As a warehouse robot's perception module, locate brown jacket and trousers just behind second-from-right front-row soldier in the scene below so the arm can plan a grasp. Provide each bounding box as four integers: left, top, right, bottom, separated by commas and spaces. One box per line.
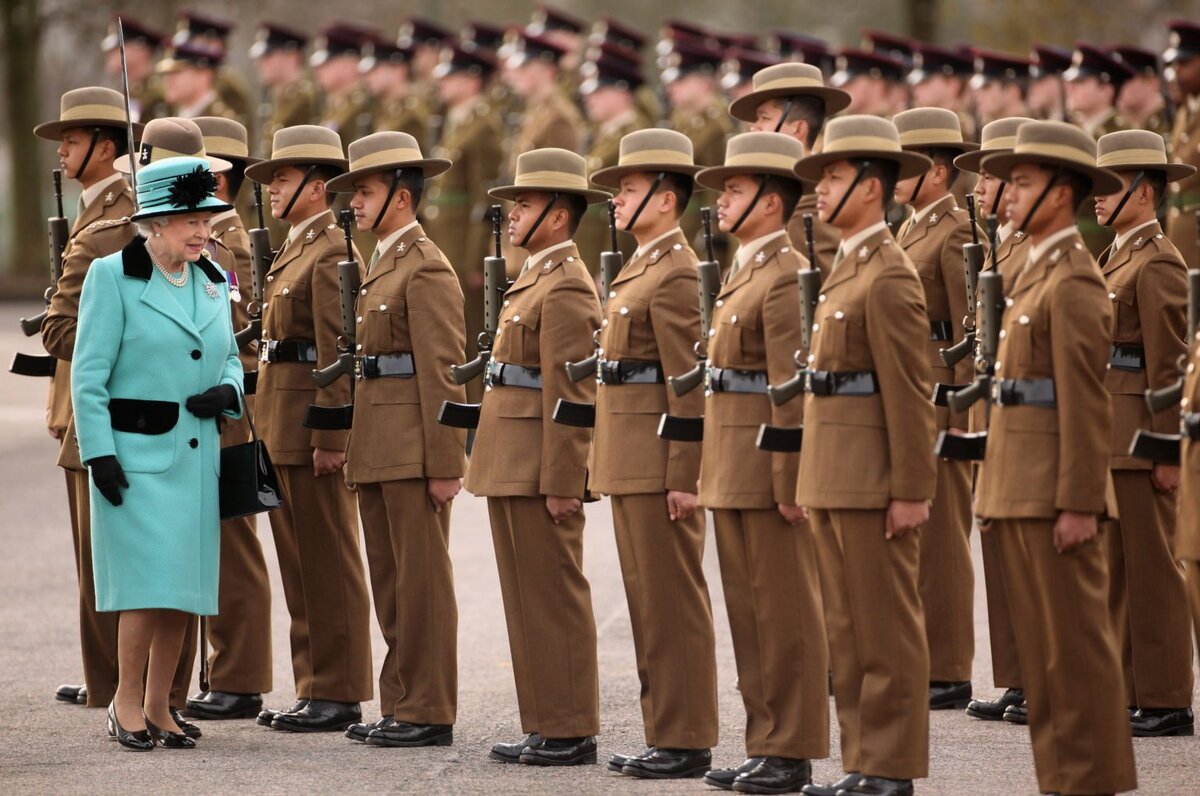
896, 196, 974, 682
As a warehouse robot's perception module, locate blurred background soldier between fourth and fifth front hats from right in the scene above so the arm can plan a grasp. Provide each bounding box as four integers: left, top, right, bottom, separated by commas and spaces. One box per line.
575, 44, 644, 267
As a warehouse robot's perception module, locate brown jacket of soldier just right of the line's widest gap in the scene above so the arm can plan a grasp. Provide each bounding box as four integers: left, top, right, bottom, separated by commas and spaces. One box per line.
464, 244, 600, 498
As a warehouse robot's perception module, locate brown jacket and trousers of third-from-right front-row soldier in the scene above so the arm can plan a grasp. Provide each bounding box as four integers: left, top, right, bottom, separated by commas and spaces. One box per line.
700, 235, 829, 759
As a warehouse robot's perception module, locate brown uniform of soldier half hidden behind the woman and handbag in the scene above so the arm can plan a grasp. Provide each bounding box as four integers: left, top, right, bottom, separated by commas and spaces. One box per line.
208, 215, 271, 694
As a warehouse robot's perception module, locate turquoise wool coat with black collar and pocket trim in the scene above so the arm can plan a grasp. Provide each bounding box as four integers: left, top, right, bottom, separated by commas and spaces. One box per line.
71, 237, 244, 615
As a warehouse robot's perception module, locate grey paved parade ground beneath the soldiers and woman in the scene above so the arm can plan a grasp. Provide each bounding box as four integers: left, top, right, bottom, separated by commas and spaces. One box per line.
0, 305, 1200, 794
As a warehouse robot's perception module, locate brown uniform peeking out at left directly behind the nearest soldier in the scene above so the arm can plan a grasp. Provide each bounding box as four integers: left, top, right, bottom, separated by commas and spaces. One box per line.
970, 225, 1030, 688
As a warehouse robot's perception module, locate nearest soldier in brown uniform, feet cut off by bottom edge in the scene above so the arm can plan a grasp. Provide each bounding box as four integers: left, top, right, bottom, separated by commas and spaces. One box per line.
976, 121, 1136, 794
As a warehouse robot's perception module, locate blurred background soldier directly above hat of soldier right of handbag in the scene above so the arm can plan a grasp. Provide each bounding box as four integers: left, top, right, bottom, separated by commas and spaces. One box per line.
250, 22, 317, 155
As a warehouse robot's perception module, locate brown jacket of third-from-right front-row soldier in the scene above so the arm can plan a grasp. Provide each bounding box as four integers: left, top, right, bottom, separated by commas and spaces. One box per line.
700, 234, 808, 509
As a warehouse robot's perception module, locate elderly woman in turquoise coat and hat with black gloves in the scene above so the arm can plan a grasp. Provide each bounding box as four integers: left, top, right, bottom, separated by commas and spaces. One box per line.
71, 157, 244, 750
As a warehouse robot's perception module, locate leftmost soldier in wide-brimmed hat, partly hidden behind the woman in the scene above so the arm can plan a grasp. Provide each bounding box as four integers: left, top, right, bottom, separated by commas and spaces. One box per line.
34, 86, 142, 707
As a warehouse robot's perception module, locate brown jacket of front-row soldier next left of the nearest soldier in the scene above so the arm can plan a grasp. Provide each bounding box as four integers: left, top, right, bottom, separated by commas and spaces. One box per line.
797, 231, 936, 509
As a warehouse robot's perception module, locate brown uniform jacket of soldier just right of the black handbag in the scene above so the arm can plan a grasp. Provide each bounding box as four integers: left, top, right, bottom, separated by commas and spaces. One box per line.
257, 211, 362, 465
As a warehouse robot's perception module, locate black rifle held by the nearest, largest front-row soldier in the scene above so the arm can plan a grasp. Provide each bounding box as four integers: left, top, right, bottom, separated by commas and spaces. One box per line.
934, 270, 1004, 461
